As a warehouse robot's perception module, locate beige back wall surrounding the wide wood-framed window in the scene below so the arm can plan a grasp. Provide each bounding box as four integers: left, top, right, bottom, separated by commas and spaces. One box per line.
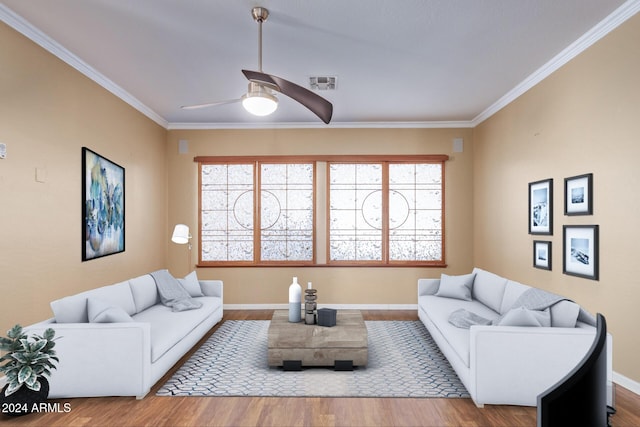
167, 129, 473, 305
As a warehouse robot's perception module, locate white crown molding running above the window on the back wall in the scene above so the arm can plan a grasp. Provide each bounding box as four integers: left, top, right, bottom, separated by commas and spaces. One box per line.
167, 120, 474, 130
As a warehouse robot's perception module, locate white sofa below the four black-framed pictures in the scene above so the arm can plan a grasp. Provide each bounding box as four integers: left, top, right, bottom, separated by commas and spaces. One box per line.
418, 268, 612, 407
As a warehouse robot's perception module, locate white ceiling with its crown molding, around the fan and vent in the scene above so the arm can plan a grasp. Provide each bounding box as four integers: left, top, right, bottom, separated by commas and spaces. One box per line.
0, 0, 640, 128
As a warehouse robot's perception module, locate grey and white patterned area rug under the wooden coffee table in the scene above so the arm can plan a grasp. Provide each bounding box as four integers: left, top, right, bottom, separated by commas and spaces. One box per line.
157, 320, 469, 398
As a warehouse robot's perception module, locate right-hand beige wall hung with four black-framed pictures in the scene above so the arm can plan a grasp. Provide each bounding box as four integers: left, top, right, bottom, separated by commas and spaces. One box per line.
473, 15, 640, 381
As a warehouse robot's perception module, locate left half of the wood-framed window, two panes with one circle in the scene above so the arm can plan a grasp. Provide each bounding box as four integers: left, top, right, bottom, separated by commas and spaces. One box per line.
200, 162, 315, 264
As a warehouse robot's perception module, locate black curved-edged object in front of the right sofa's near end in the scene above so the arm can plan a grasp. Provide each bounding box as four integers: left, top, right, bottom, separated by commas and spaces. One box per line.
537, 313, 614, 427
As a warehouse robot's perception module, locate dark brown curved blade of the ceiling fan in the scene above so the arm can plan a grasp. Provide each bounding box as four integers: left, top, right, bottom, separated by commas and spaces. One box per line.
242, 70, 333, 124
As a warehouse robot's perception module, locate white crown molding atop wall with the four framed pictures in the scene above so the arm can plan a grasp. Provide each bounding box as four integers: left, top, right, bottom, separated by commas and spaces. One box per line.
471, 0, 640, 127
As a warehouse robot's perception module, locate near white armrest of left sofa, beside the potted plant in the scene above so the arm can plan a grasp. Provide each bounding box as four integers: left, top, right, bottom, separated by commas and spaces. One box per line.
25, 319, 153, 398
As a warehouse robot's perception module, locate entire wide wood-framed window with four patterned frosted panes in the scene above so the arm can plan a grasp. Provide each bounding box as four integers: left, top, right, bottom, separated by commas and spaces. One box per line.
195, 156, 448, 266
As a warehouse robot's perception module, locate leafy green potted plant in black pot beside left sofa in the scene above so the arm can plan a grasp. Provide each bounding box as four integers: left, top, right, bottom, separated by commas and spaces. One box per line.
0, 325, 59, 415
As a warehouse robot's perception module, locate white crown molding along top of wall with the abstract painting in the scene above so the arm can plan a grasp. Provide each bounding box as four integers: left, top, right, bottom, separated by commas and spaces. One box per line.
0, 4, 167, 128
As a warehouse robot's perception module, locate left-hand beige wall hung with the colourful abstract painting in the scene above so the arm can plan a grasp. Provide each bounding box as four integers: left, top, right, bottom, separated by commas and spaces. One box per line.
0, 23, 168, 335
